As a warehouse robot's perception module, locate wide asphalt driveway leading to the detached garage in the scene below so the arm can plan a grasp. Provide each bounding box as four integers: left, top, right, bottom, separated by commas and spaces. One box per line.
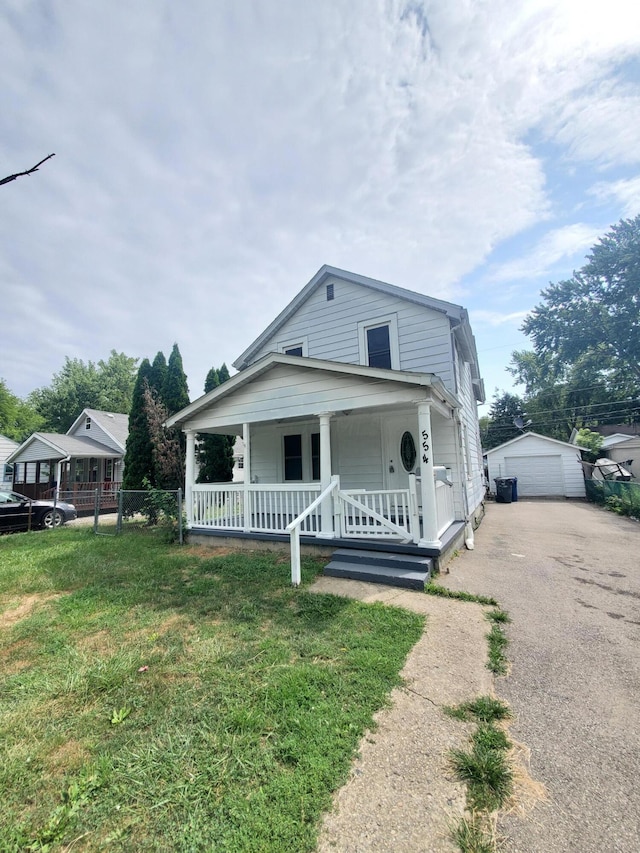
441, 501, 640, 853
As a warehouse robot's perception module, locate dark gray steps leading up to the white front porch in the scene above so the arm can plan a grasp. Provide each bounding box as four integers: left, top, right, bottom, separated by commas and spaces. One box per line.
323, 548, 433, 590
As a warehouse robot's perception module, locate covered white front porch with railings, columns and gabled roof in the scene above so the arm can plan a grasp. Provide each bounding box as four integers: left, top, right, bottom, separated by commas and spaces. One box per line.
167, 355, 476, 582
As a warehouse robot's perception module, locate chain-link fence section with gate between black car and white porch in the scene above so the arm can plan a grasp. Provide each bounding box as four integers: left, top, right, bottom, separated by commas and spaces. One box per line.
93, 489, 184, 545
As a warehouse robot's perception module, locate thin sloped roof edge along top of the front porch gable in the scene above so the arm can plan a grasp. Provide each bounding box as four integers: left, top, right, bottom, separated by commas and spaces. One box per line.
165, 353, 459, 428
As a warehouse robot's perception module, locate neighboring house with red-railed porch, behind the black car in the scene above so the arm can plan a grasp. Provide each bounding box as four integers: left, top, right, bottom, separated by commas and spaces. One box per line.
7, 409, 129, 504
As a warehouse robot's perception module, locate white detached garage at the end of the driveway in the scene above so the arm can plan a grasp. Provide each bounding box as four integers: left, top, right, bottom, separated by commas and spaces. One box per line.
487, 432, 585, 498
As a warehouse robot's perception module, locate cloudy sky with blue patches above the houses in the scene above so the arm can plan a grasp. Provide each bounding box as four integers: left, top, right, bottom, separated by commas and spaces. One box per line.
0, 0, 640, 412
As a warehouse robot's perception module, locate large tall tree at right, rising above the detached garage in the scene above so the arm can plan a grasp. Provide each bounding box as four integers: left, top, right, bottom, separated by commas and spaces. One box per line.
522, 215, 640, 388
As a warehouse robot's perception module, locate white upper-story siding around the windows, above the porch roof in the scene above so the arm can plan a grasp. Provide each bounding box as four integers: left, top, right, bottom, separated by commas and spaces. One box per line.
251, 279, 454, 391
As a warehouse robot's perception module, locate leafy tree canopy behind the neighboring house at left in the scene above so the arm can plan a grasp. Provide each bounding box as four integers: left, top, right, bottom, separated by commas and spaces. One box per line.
28, 350, 138, 433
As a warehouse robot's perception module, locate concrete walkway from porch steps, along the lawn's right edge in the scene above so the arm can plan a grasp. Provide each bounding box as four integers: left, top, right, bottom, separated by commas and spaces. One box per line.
311, 577, 492, 853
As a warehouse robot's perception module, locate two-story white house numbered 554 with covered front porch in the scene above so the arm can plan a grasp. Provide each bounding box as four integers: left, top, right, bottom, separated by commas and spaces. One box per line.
167, 266, 484, 554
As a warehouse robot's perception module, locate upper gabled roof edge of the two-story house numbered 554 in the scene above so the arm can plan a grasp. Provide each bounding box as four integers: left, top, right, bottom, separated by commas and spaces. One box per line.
233, 264, 478, 378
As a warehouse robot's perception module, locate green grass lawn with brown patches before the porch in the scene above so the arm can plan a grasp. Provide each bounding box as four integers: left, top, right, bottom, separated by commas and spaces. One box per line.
0, 529, 423, 853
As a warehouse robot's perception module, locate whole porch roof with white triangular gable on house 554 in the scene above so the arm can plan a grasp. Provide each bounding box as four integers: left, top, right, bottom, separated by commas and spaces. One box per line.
165, 353, 460, 432
